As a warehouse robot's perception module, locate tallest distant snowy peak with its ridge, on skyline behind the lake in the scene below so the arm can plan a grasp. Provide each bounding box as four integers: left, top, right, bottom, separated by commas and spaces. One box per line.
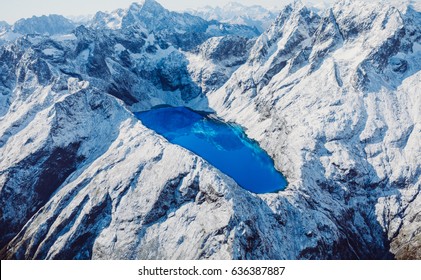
90, 0, 259, 50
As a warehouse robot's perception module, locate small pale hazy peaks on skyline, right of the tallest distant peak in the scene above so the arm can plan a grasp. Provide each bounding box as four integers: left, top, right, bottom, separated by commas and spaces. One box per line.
187, 2, 278, 32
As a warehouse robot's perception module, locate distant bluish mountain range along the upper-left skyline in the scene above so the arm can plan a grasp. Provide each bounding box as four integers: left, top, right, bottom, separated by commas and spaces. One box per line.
0, 0, 260, 49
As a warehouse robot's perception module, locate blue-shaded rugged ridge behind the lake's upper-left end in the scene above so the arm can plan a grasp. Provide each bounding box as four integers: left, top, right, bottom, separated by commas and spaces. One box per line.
0, 23, 207, 120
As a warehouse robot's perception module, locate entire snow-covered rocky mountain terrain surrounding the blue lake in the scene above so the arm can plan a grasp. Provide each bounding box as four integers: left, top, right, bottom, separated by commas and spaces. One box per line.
0, 0, 421, 259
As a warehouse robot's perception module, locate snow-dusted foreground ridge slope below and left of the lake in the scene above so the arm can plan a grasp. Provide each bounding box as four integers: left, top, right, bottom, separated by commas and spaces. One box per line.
0, 78, 286, 259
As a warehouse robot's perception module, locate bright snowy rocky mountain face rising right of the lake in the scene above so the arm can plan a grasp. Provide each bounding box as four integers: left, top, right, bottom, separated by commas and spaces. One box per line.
209, 1, 421, 258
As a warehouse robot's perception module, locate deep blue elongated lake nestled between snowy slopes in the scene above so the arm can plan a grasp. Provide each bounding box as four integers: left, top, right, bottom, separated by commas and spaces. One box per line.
136, 107, 286, 193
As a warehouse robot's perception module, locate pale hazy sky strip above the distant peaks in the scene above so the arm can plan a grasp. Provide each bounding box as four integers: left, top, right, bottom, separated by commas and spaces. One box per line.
0, 0, 289, 23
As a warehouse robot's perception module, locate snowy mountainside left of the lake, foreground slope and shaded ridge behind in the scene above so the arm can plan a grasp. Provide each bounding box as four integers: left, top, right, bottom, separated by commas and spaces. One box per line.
0, 20, 279, 259
